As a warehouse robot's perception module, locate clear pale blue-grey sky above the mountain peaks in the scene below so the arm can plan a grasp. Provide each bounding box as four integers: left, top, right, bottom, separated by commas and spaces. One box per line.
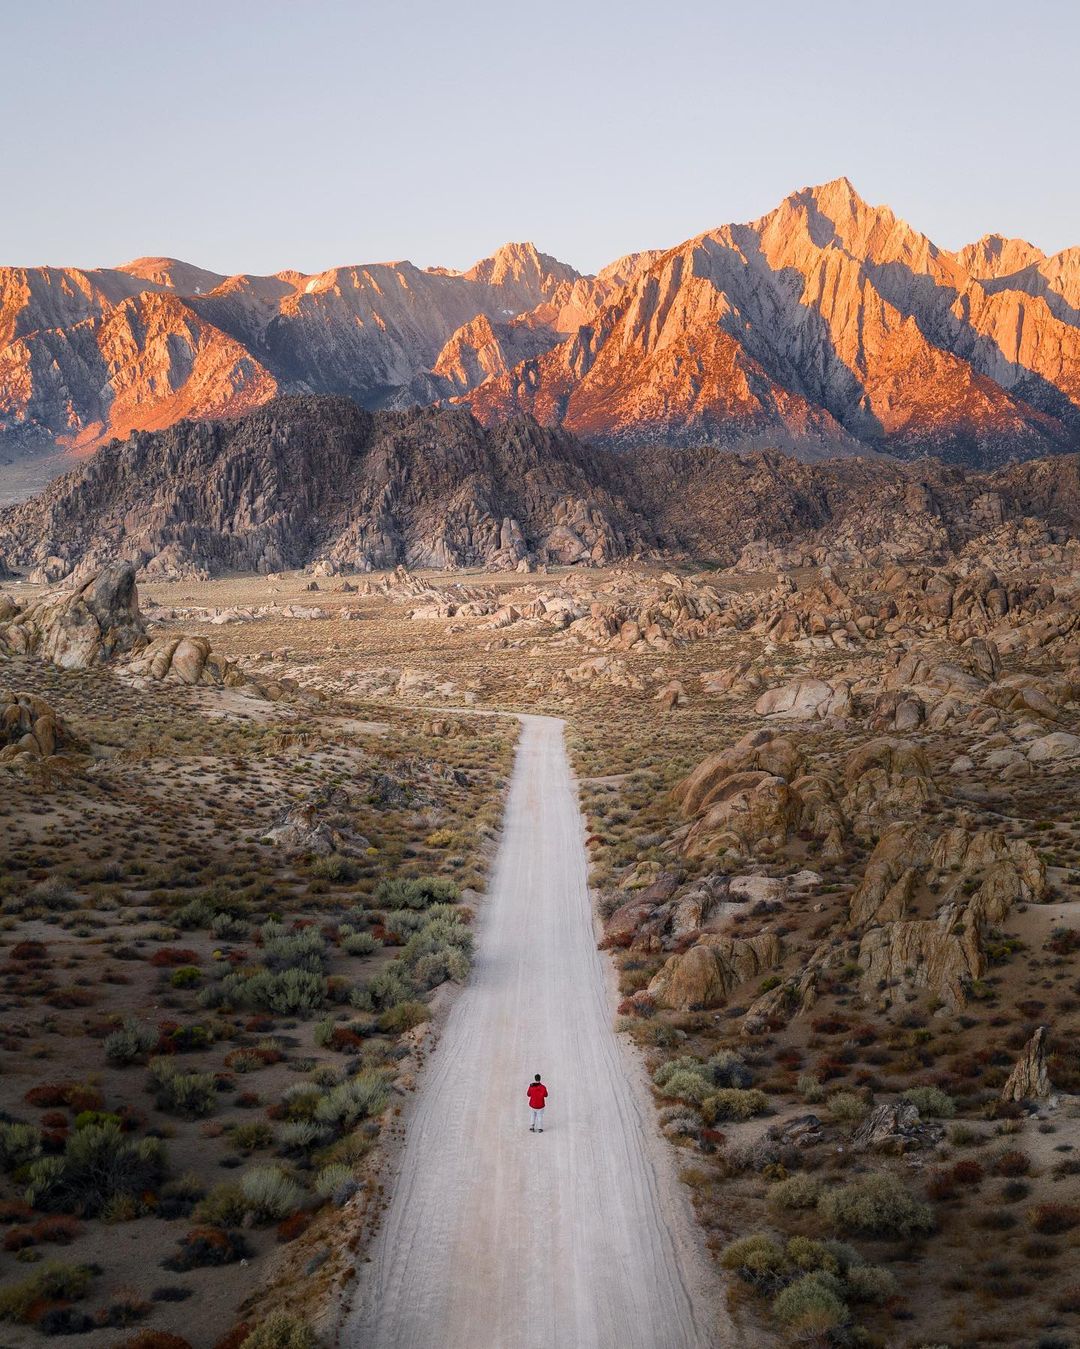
0, 0, 1080, 272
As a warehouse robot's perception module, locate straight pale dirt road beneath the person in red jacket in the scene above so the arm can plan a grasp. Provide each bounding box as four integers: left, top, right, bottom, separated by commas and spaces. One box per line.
342, 716, 733, 1349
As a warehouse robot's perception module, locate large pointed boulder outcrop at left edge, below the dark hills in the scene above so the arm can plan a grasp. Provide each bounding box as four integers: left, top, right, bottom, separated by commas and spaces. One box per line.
0, 563, 146, 669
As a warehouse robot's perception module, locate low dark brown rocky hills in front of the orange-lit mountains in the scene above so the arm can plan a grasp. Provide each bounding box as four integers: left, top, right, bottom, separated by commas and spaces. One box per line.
0, 395, 1080, 581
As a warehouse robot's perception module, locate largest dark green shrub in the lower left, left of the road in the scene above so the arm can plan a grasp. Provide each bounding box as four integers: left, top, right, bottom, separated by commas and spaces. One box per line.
26, 1124, 166, 1217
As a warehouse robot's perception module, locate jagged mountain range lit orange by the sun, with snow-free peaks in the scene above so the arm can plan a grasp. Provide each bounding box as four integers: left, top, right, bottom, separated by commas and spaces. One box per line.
0, 178, 1080, 468
